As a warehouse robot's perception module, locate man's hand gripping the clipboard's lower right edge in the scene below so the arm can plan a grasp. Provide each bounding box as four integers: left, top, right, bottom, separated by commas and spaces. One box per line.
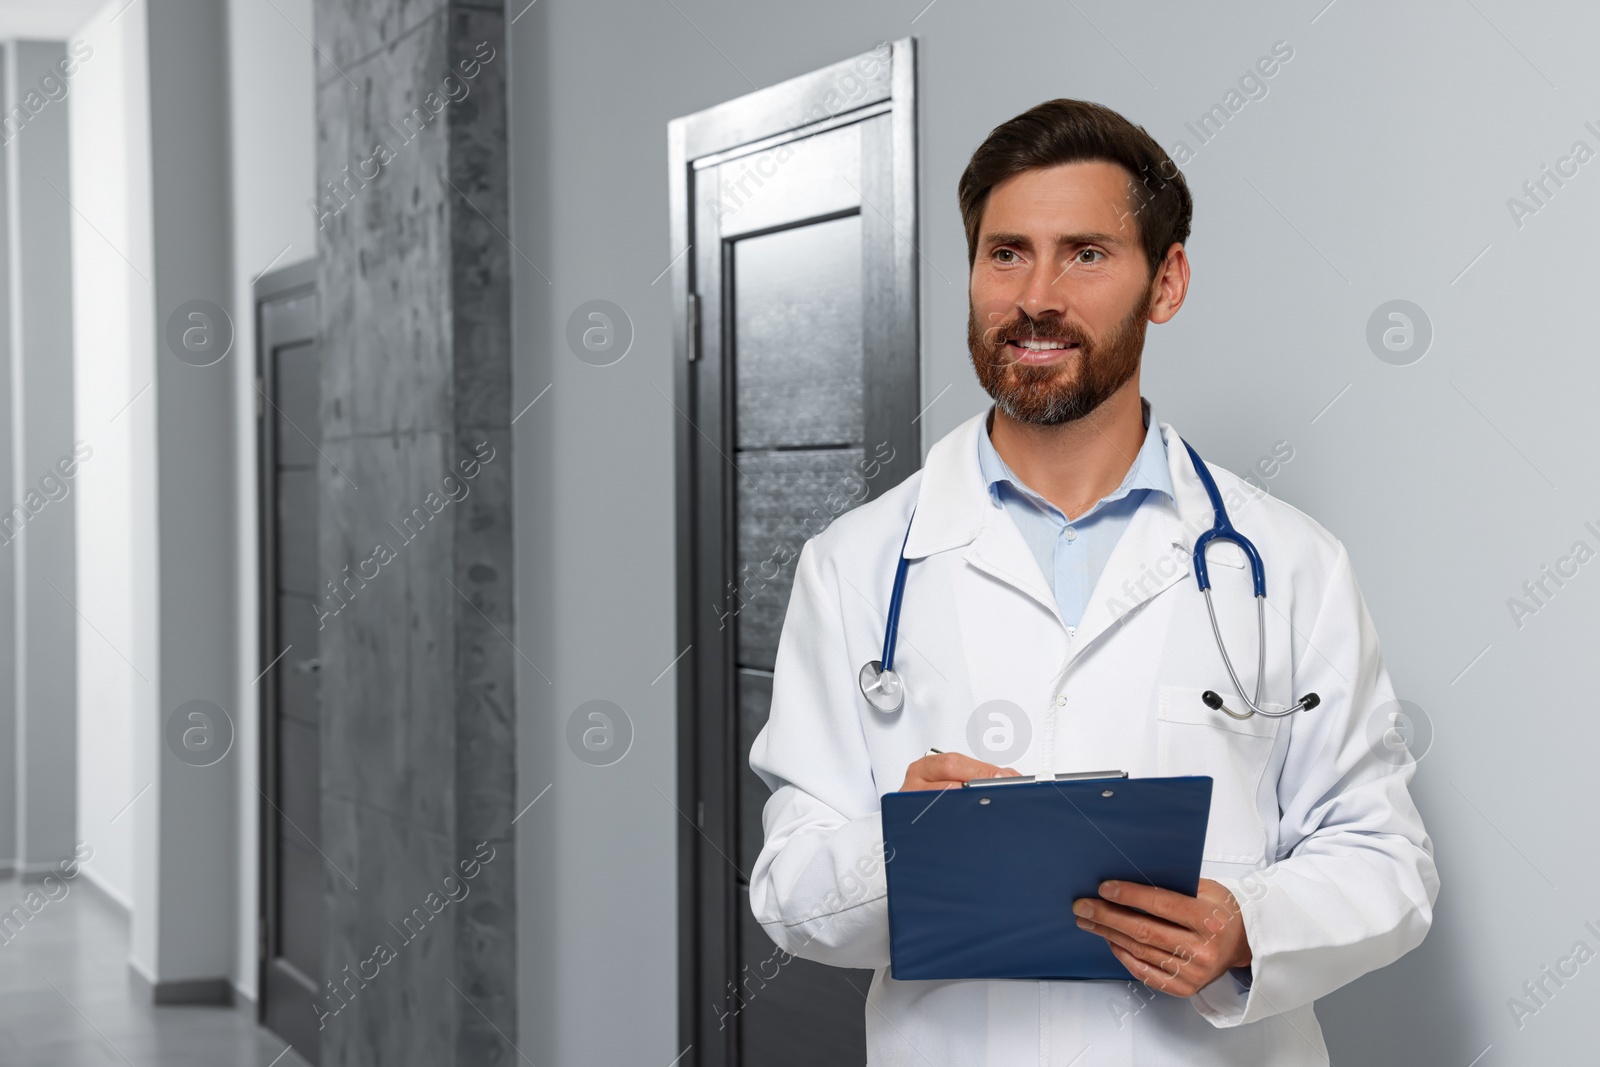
1075, 883, 1250, 997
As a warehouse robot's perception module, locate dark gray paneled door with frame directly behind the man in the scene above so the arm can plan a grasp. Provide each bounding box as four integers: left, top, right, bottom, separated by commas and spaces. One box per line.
677, 42, 920, 1067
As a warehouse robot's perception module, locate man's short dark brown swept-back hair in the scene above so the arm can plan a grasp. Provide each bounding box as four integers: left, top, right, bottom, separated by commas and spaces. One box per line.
958, 99, 1194, 277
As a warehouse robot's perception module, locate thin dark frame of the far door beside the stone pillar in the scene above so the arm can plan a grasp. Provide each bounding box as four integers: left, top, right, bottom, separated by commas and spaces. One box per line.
251, 258, 318, 1062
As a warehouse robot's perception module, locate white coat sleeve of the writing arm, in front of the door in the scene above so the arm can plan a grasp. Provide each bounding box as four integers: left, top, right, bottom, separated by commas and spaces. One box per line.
750, 541, 890, 968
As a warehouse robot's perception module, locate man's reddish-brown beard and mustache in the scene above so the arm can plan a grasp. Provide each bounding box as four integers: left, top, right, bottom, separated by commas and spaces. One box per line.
966, 291, 1152, 426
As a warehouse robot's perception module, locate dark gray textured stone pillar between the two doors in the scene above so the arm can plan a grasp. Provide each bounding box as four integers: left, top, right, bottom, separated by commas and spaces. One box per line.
314, 0, 525, 1067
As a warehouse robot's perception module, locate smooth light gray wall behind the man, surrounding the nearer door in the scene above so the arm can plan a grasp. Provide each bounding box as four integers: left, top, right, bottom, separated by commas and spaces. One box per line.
509, 0, 1600, 1065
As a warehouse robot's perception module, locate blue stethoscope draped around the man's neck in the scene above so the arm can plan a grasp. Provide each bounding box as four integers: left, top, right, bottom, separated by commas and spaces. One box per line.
859, 442, 1322, 718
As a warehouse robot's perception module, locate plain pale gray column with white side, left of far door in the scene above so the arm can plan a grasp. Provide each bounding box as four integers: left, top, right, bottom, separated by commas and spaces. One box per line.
125, 0, 236, 1003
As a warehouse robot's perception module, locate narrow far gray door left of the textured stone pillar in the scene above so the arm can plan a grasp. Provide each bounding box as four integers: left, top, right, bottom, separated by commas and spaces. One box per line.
256, 262, 325, 1064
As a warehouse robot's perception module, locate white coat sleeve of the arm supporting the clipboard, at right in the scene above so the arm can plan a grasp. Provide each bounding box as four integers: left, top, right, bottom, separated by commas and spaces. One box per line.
1194, 545, 1438, 1027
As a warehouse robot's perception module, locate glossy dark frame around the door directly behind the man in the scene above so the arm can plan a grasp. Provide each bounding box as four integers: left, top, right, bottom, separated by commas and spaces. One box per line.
667, 37, 922, 1067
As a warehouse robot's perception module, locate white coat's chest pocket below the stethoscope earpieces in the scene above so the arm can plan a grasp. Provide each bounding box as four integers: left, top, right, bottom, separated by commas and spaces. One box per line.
1155, 685, 1278, 864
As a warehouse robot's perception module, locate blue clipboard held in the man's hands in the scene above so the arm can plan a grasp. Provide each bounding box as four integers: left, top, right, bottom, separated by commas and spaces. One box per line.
882, 776, 1211, 981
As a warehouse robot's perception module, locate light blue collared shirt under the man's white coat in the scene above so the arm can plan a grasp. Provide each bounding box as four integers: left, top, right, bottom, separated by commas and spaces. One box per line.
978, 400, 1173, 630
